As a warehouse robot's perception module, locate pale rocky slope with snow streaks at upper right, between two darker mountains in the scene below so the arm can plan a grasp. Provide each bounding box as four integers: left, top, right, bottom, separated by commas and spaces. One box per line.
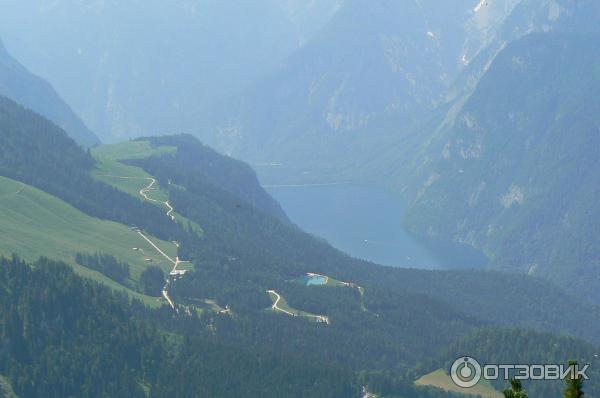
330, 0, 600, 191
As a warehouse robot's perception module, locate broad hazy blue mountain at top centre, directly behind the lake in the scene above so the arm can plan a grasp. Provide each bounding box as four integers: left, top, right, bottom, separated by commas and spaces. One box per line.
209, 0, 476, 175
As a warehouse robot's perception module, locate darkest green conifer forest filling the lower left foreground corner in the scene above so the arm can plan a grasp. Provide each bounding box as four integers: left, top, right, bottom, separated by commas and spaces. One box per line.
0, 258, 359, 398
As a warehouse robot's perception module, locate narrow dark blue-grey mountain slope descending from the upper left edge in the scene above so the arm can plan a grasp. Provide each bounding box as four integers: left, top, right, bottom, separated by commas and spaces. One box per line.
0, 37, 100, 146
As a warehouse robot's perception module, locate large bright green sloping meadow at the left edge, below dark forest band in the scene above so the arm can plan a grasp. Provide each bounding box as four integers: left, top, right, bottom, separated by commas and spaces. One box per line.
0, 177, 177, 305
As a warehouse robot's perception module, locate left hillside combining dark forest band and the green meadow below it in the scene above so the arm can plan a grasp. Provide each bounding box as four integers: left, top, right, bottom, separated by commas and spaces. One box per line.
0, 97, 195, 306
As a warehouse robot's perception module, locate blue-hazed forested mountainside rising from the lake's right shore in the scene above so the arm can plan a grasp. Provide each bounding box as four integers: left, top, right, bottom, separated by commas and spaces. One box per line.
407, 34, 600, 303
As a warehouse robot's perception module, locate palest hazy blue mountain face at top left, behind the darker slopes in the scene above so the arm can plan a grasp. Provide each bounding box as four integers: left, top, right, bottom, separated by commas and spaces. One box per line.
0, 0, 298, 142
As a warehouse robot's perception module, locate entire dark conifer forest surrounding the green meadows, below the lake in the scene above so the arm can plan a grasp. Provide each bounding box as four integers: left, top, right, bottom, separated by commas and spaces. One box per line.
0, 100, 600, 398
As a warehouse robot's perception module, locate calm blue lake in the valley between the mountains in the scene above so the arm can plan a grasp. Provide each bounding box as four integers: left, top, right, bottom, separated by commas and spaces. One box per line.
266, 184, 486, 269
